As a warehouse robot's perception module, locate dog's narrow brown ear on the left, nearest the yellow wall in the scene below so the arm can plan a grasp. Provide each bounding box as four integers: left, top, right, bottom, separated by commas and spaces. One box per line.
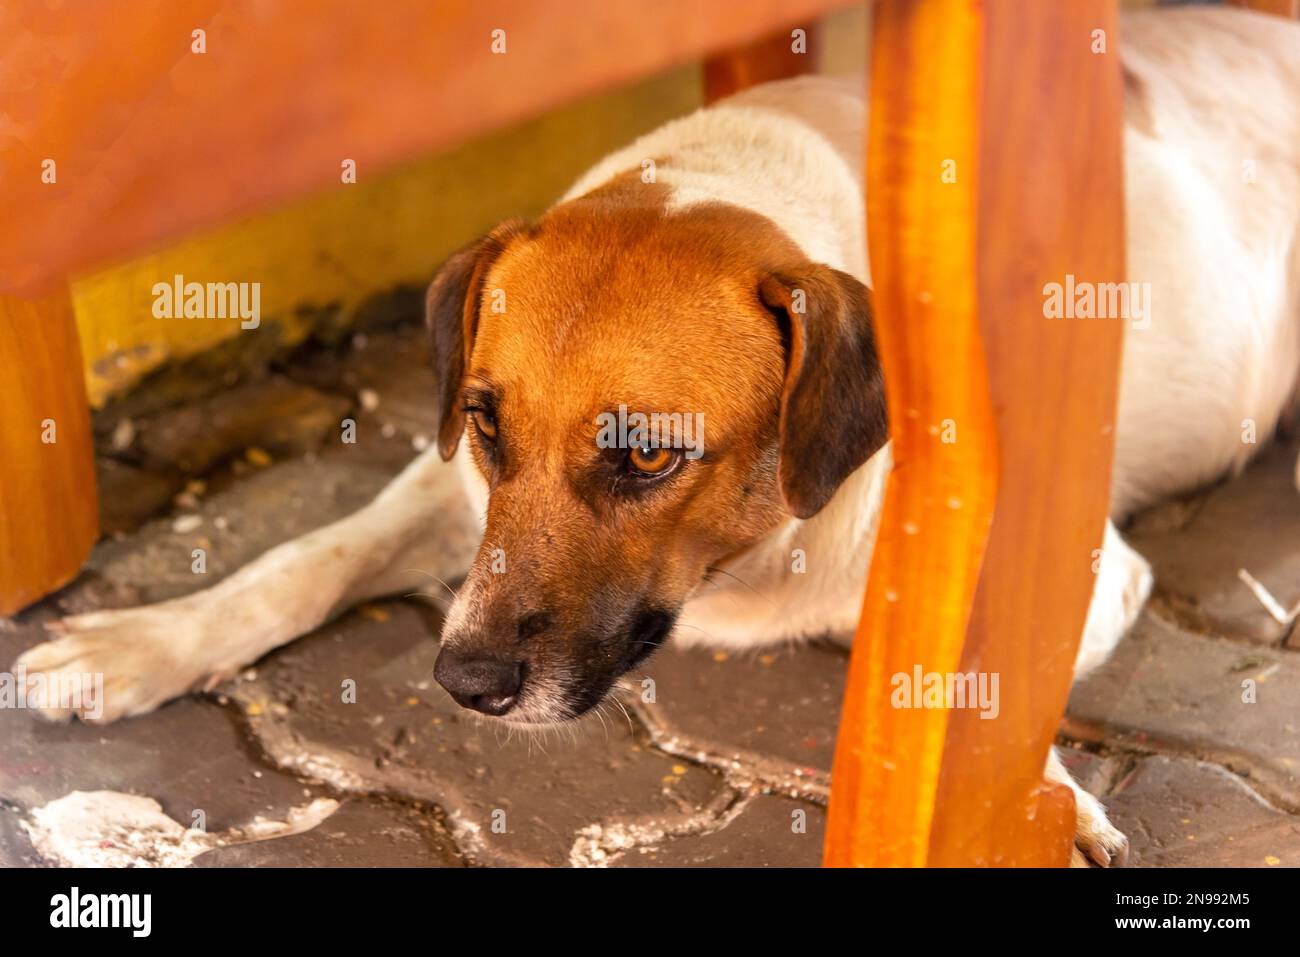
424, 220, 524, 459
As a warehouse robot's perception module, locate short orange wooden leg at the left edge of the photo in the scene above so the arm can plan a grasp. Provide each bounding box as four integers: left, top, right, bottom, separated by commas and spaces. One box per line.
0, 290, 99, 615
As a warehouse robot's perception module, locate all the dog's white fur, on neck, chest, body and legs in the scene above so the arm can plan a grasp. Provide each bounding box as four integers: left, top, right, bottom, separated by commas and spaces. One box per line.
12, 3, 1300, 863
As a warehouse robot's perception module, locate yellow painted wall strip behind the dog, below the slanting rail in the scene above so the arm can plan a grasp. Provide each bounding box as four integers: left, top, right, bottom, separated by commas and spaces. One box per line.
72, 68, 702, 408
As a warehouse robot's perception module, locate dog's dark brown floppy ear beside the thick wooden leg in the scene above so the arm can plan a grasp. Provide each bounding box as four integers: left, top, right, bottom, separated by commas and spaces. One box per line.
758, 265, 889, 519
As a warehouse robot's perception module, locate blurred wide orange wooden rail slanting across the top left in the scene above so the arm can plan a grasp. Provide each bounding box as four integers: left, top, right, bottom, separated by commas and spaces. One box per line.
0, 0, 853, 294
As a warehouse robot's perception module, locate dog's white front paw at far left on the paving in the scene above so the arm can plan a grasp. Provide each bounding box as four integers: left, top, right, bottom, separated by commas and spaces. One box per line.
14, 602, 208, 723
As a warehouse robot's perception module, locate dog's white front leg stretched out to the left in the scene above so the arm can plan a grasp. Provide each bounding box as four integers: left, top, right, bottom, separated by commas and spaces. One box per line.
16, 447, 478, 722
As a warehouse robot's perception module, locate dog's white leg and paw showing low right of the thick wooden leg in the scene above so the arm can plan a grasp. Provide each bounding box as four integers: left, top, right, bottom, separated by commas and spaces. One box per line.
1044, 520, 1152, 867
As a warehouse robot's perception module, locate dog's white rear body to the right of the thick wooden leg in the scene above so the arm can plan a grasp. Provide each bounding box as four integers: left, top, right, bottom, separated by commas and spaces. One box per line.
1112, 9, 1300, 520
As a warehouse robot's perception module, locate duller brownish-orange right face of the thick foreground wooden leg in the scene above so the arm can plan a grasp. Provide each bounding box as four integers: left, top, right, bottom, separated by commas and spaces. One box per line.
930, 0, 1141, 866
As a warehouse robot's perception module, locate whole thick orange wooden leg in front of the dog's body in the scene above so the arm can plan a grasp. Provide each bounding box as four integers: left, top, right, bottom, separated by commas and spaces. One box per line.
826, 0, 1125, 866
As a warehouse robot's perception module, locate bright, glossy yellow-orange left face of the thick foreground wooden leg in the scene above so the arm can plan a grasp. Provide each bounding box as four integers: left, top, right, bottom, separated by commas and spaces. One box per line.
826, 0, 997, 866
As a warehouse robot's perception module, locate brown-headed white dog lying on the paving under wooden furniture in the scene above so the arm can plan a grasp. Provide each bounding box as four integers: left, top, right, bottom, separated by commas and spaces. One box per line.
12, 3, 1300, 865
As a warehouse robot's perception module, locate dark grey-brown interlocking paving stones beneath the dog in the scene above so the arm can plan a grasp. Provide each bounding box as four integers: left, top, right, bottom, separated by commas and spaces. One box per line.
0, 321, 1300, 867
